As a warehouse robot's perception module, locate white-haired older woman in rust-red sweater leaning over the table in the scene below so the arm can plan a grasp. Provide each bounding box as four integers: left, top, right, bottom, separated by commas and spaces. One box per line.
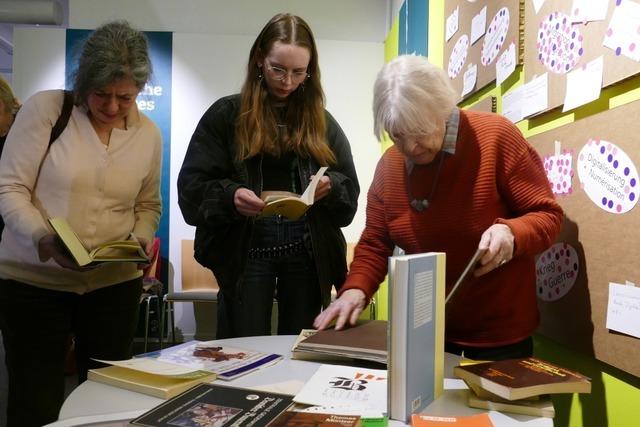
315, 55, 563, 360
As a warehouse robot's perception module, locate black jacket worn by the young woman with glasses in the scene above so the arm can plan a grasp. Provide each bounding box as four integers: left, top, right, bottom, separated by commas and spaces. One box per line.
178, 95, 360, 305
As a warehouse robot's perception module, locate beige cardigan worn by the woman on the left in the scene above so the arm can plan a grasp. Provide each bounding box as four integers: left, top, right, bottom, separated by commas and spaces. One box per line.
0, 90, 162, 294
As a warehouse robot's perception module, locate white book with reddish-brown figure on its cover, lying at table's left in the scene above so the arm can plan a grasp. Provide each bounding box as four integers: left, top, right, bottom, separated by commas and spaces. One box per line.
137, 341, 282, 380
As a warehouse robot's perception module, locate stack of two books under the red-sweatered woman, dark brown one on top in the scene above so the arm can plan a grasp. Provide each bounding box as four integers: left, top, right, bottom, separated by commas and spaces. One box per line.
453, 357, 591, 418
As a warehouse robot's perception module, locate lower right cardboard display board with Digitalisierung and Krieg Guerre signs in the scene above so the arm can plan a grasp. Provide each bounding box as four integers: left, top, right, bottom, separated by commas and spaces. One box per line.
529, 101, 640, 376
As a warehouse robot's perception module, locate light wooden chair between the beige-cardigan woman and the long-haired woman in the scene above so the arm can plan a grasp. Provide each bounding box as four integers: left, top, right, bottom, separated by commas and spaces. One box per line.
160, 240, 219, 348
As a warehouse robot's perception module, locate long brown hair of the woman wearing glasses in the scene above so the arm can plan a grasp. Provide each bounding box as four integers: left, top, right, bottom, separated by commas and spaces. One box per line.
236, 13, 336, 165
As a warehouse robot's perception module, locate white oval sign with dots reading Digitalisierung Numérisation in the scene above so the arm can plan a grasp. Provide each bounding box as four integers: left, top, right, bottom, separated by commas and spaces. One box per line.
577, 139, 638, 214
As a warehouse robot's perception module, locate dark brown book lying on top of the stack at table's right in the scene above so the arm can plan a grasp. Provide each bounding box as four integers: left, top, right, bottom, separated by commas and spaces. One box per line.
453, 357, 591, 400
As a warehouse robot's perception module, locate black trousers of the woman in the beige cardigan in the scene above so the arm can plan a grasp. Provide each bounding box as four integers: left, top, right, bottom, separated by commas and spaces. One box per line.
0, 279, 142, 427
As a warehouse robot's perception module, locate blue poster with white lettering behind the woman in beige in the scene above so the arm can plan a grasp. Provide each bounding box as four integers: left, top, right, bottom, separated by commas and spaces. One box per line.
65, 29, 173, 268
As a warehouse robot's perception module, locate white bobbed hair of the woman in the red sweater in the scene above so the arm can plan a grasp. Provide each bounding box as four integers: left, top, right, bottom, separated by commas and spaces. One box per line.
373, 55, 458, 140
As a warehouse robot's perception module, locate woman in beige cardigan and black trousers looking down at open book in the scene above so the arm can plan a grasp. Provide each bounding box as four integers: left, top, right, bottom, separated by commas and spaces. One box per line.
0, 22, 162, 427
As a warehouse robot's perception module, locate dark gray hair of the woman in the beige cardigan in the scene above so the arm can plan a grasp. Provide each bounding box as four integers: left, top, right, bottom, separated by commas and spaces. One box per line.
73, 21, 152, 104
